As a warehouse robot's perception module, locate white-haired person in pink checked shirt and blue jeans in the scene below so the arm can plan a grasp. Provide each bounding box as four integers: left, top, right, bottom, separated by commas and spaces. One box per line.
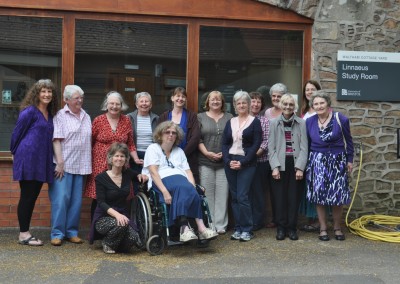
49, 85, 92, 246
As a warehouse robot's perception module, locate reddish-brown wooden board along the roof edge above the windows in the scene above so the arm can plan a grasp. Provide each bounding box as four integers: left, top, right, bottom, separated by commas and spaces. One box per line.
0, 0, 312, 24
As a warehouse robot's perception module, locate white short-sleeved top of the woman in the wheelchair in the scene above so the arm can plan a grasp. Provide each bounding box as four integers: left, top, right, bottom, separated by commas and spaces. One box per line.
142, 143, 190, 188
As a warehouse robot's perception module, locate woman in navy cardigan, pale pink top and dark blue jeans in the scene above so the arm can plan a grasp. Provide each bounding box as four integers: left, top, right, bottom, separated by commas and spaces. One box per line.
222, 91, 262, 242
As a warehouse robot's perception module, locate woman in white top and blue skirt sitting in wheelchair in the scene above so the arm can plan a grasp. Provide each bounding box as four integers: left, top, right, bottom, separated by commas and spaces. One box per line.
142, 121, 218, 242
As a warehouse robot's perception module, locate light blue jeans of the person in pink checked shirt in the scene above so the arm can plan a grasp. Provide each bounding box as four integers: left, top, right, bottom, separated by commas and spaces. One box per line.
49, 172, 83, 240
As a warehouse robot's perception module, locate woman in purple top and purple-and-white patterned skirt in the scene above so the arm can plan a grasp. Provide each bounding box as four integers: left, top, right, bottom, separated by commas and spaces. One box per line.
306, 91, 354, 241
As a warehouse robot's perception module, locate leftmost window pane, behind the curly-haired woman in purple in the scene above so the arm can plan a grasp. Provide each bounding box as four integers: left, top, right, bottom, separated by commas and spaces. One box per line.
0, 16, 62, 151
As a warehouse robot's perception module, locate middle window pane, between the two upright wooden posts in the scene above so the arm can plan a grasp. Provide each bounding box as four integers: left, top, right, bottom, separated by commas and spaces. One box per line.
75, 20, 187, 119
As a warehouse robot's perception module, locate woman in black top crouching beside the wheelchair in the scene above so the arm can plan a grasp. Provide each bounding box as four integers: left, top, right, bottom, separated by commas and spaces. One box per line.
90, 142, 148, 253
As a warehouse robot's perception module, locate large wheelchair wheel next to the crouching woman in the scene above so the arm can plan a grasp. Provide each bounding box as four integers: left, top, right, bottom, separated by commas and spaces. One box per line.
131, 192, 153, 244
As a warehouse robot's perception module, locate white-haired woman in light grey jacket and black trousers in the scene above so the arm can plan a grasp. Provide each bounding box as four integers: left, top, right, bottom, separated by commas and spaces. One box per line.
268, 94, 308, 241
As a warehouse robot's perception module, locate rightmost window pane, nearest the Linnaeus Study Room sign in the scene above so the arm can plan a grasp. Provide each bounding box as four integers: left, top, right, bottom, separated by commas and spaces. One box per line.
199, 27, 303, 111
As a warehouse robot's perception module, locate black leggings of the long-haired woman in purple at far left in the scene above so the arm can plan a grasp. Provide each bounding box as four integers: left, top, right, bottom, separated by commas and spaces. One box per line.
17, 180, 43, 232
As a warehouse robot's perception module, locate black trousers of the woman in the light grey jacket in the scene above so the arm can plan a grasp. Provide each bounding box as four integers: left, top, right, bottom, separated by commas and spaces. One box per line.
271, 156, 304, 231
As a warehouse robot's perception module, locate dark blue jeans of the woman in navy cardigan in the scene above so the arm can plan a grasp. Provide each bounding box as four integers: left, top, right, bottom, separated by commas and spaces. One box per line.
225, 165, 256, 232
